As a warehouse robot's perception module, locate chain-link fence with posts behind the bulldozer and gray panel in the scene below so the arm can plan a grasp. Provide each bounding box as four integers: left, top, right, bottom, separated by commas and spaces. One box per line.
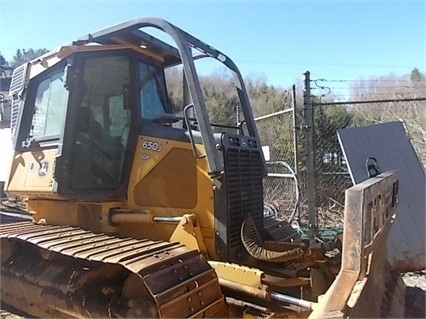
251, 74, 426, 232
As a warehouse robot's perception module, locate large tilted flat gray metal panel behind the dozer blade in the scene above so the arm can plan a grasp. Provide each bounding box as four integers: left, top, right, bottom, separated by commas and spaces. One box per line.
337, 122, 426, 271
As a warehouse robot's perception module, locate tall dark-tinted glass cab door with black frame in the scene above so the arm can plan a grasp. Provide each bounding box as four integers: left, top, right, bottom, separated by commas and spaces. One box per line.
59, 50, 136, 200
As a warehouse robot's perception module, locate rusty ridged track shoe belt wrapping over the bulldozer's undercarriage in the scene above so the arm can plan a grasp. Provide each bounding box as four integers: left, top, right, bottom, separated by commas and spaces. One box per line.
0, 222, 223, 318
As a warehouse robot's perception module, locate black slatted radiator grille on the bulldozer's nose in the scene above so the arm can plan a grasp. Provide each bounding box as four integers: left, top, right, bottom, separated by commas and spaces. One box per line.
224, 138, 263, 259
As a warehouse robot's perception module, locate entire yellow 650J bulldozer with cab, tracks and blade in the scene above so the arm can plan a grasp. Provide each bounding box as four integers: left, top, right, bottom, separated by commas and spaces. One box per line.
0, 18, 404, 318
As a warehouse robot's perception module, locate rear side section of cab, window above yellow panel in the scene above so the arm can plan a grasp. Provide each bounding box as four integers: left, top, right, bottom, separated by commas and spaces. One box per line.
7, 63, 69, 194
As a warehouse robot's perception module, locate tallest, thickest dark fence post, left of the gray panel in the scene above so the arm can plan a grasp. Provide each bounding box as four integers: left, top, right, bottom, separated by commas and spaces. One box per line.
303, 71, 316, 244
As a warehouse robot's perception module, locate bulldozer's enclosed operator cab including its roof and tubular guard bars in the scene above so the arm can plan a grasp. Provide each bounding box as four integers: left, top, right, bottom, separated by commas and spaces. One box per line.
9, 18, 264, 200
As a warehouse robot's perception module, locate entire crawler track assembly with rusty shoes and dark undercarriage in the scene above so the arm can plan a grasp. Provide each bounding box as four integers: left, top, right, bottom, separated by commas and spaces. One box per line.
0, 222, 225, 318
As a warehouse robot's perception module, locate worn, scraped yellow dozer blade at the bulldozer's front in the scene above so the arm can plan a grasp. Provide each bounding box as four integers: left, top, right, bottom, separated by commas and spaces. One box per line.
310, 171, 403, 318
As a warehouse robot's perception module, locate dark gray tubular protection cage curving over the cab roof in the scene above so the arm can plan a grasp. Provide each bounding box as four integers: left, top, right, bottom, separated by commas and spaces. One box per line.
74, 18, 266, 176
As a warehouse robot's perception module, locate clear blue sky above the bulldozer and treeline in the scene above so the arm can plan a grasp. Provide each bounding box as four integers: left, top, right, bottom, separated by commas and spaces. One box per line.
0, 0, 426, 87
